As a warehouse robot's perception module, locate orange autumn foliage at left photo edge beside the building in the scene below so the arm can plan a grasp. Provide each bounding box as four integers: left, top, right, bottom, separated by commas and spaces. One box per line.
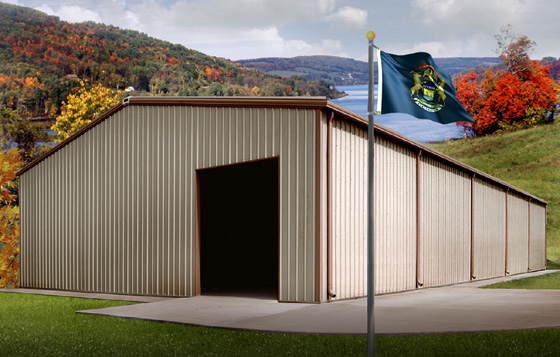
0, 149, 21, 288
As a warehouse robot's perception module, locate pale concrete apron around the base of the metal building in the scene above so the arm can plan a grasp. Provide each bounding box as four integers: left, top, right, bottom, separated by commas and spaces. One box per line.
2, 271, 560, 335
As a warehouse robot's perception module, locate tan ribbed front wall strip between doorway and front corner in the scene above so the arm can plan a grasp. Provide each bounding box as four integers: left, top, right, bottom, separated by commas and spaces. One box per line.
278, 109, 315, 301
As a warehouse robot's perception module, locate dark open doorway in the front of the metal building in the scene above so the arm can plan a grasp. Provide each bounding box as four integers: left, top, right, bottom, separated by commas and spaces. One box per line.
198, 158, 279, 299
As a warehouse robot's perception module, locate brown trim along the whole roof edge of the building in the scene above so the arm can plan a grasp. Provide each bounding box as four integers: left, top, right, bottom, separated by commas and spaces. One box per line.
16, 97, 548, 205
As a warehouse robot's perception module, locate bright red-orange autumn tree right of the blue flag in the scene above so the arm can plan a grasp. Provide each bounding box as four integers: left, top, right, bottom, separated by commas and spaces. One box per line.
455, 27, 558, 135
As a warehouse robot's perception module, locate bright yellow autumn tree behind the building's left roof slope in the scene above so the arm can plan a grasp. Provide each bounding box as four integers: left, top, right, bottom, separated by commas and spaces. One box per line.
51, 81, 124, 141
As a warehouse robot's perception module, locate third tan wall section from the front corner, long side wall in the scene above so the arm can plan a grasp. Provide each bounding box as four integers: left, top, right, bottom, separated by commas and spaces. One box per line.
473, 179, 506, 279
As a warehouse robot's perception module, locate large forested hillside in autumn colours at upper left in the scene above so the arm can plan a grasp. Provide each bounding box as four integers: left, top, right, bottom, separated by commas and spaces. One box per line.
0, 3, 342, 116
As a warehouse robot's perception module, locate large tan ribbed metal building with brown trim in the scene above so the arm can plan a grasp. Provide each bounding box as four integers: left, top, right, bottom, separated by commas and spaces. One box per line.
19, 97, 546, 302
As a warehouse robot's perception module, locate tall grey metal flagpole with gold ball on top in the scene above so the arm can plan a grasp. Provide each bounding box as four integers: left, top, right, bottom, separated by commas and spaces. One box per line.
366, 31, 379, 357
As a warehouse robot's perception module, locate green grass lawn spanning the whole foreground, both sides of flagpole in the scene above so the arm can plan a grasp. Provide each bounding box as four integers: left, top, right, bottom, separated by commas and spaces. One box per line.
0, 292, 560, 357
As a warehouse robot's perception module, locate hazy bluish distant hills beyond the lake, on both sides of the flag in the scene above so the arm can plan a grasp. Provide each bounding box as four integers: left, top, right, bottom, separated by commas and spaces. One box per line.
237, 56, 502, 85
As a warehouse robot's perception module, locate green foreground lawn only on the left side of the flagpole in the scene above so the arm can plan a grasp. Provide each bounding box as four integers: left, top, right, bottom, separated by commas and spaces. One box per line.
0, 293, 366, 356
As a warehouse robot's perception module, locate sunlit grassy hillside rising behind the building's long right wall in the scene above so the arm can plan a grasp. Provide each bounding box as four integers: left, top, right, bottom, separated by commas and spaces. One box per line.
432, 122, 560, 269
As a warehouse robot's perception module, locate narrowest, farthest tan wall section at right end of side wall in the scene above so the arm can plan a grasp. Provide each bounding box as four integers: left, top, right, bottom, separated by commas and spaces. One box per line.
529, 202, 546, 271
